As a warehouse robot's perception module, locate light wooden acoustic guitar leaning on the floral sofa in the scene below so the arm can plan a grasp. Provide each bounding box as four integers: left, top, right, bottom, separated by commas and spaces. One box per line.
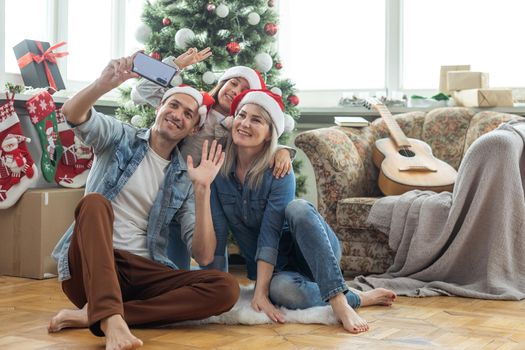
365, 99, 457, 196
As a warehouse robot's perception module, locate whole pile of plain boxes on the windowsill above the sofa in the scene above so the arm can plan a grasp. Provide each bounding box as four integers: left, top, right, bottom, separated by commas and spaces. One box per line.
439, 65, 513, 107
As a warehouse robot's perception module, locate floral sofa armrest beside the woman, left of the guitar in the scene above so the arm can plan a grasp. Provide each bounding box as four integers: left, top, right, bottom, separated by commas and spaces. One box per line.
295, 127, 369, 228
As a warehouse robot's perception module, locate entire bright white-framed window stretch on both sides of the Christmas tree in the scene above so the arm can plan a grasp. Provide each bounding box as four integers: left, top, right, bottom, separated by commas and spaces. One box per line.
0, 0, 525, 102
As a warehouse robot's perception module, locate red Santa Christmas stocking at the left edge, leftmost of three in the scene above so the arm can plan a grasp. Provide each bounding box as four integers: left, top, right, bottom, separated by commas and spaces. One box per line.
0, 96, 38, 209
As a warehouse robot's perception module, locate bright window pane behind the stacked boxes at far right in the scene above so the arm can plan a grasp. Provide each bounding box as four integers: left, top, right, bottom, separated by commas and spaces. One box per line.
403, 0, 525, 89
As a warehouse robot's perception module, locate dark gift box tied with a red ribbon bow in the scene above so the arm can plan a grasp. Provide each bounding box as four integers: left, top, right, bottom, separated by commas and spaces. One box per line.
13, 39, 69, 91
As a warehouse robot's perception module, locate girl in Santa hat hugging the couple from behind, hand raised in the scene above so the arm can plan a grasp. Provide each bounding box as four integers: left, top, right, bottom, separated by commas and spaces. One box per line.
131, 47, 295, 177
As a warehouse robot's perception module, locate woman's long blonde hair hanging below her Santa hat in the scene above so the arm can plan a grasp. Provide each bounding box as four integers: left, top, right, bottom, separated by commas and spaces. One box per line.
221, 104, 277, 190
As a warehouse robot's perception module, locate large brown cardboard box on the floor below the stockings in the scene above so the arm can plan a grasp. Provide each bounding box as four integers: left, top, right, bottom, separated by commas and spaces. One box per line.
0, 188, 84, 279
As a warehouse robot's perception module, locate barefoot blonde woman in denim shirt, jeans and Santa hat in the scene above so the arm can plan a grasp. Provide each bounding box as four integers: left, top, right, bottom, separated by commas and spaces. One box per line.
208, 90, 396, 333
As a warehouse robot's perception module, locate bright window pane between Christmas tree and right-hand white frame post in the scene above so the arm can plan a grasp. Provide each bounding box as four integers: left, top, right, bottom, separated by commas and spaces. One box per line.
279, 0, 385, 90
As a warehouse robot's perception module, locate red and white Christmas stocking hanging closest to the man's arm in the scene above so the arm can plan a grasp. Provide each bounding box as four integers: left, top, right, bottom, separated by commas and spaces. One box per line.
55, 109, 93, 188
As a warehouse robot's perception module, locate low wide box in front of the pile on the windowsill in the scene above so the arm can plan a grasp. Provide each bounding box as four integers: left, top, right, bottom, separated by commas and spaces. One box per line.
454, 89, 514, 107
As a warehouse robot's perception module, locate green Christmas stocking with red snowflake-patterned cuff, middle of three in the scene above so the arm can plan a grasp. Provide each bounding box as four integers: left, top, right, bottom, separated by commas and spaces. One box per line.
26, 91, 62, 182
